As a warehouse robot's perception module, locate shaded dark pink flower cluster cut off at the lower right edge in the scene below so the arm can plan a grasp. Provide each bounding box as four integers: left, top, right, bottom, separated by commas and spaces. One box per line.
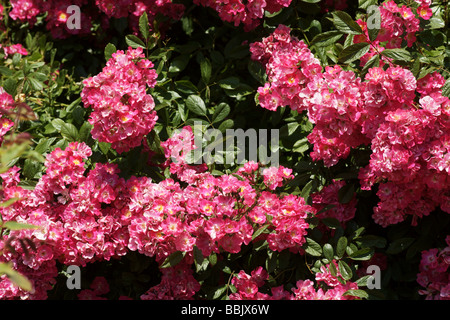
417, 236, 450, 300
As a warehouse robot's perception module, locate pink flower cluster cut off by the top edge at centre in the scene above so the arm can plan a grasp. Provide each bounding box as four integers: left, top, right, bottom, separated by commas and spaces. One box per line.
194, 0, 292, 31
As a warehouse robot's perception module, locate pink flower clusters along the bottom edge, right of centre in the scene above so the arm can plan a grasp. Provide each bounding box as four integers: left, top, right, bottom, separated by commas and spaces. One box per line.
230, 261, 358, 300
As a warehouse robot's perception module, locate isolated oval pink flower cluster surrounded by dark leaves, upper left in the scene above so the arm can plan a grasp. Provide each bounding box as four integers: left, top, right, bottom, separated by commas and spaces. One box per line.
81, 48, 158, 153
